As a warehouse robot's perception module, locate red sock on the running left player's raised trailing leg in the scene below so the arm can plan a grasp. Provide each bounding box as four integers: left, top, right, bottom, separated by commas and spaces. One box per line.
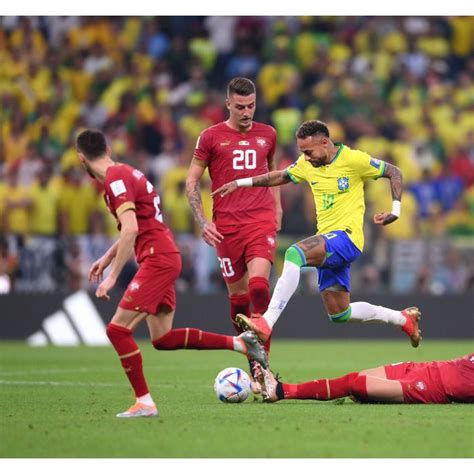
152, 328, 234, 351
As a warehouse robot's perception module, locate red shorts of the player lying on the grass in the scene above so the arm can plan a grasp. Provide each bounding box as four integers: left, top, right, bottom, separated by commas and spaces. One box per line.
385, 362, 451, 403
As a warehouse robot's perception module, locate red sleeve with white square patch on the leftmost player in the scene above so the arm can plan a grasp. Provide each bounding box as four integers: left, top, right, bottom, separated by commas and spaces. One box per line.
104, 166, 137, 217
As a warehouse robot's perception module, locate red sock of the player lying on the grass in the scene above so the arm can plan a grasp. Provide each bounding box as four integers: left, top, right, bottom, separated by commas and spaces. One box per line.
281, 372, 359, 400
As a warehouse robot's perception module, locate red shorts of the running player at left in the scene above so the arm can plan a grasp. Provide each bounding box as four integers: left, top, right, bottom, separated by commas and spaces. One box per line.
119, 253, 181, 314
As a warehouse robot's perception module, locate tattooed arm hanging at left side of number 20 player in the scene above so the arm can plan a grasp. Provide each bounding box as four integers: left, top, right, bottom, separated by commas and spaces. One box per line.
186, 161, 224, 247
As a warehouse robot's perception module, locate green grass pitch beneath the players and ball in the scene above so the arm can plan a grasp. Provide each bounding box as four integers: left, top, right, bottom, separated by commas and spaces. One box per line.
0, 340, 474, 458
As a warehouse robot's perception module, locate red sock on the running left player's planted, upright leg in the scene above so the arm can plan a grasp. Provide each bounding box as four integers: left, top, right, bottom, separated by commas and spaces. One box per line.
107, 323, 149, 398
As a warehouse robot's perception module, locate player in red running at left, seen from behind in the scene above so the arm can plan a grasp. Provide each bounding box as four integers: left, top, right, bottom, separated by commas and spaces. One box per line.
76, 130, 267, 418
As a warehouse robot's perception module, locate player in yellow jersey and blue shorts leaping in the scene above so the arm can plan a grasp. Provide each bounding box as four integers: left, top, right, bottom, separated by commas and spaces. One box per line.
212, 120, 421, 347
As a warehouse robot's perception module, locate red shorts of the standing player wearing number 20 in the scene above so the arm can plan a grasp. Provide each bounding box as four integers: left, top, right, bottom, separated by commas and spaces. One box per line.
216, 222, 276, 283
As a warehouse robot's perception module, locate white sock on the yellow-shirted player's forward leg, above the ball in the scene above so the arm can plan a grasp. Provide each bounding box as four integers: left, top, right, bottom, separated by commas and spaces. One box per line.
263, 260, 301, 328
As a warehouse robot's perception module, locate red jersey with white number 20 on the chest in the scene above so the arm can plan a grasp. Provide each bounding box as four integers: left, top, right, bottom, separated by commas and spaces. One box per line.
194, 122, 276, 227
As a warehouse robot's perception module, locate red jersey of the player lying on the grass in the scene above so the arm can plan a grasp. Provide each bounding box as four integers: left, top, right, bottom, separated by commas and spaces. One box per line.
434, 353, 474, 403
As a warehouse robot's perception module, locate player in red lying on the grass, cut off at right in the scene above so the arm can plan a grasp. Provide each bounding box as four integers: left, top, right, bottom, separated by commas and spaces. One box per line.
260, 353, 474, 403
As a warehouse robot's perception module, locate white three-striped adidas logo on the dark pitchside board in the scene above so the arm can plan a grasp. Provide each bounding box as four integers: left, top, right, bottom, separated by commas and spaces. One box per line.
26, 291, 109, 346
